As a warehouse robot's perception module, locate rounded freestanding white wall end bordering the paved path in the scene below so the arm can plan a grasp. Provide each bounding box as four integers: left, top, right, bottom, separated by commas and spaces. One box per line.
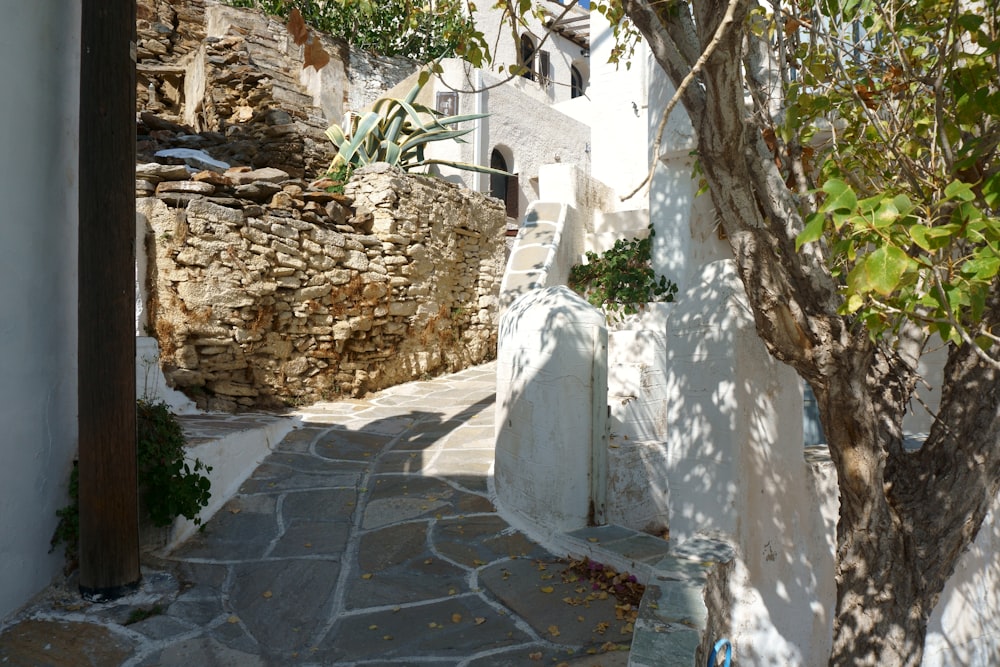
494, 286, 607, 532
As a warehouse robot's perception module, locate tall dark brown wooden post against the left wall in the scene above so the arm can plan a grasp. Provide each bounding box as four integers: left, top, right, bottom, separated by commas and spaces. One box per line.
78, 0, 140, 600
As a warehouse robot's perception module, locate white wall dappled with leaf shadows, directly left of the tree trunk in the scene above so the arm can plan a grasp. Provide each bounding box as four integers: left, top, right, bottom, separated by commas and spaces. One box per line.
667, 260, 833, 665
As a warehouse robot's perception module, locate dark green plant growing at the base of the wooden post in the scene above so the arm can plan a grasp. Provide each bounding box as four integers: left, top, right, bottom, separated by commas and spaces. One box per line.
51, 400, 212, 564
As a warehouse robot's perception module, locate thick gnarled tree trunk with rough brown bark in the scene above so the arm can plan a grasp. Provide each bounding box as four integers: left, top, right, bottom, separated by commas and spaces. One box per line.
623, 0, 1000, 667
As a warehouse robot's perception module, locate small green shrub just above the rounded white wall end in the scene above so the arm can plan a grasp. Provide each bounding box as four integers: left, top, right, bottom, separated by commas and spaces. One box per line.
569, 225, 677, 320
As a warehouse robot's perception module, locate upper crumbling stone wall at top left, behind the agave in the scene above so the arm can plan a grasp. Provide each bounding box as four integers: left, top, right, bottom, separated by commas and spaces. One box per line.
136, 0, 417, 178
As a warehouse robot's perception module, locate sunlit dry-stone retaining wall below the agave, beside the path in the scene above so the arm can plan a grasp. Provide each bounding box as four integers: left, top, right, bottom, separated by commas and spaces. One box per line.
137, 164, 506, 410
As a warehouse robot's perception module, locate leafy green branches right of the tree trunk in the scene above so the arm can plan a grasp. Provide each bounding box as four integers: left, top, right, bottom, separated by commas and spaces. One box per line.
788, 2, 1000, 365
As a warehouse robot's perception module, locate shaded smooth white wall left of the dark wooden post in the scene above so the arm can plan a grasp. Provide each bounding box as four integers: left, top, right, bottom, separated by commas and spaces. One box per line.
0, 0, 80, 621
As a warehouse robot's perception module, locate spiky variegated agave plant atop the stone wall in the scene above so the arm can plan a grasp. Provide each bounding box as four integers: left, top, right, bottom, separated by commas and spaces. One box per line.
326, 77, 506, 174
